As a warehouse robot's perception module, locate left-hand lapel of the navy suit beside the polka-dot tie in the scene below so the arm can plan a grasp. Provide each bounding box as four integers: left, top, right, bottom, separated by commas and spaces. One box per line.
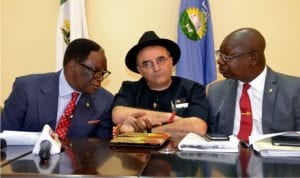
38, 72, 60, 130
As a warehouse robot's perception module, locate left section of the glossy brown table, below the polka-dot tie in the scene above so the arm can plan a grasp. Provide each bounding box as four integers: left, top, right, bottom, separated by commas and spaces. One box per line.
1, 138, 150, 177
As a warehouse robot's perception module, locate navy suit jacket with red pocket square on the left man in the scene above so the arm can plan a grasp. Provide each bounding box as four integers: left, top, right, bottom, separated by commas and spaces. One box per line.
1, 72, 113, 137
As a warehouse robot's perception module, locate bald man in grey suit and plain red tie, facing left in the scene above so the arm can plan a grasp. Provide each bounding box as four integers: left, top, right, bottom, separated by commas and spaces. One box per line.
208, 28, 300, 139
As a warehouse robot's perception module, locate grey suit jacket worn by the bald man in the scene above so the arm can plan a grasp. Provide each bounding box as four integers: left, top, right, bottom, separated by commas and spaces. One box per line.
207, 68, 300, 135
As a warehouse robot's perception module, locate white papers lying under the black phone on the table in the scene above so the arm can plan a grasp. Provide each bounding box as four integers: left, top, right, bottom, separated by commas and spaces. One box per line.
178, 133, 239, 152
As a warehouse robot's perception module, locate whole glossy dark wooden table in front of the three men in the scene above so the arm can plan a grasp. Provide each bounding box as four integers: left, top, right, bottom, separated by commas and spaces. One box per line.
1, 138, 300, 177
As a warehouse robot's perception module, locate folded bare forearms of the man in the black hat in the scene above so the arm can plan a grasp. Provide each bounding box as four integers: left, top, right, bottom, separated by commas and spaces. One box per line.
112, 106, 207, 138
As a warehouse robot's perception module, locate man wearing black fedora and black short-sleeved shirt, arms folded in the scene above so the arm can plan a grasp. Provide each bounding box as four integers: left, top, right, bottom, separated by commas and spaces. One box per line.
112, 31, 208, 137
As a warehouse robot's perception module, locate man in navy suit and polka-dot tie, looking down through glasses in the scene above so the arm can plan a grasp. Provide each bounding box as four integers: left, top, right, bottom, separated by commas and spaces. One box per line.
1, 39, 113, 137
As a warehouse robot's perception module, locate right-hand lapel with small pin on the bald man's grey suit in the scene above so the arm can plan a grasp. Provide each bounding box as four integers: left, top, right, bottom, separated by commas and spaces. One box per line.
262, 68, 277, 133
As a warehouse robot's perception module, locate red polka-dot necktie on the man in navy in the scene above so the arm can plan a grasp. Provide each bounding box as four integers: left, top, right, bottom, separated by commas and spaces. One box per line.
55, 92, 79, 139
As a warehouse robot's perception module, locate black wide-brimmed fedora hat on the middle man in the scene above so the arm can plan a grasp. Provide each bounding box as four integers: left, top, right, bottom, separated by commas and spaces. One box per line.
125, 31, 180, 73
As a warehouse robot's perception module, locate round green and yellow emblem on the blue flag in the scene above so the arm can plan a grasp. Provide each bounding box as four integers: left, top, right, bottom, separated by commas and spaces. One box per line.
179, 7, 207, 41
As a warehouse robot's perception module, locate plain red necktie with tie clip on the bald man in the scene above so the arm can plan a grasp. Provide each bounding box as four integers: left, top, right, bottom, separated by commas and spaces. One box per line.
237, 83, 252, 142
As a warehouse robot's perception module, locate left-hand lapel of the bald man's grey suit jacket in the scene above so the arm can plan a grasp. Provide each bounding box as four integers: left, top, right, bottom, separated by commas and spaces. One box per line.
218, 80, 237, 135
